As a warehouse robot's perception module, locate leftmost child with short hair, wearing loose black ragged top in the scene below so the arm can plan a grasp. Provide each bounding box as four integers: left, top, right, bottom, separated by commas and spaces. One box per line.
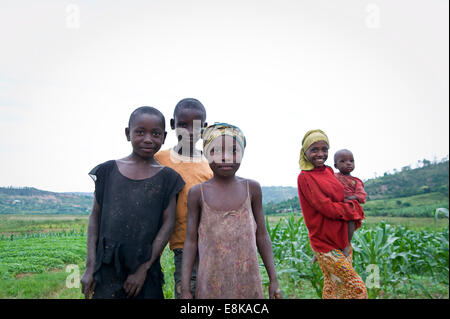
81, 107, 184, 298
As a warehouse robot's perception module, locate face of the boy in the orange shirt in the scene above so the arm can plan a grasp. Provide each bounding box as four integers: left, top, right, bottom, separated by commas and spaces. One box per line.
170, 109, 206, 145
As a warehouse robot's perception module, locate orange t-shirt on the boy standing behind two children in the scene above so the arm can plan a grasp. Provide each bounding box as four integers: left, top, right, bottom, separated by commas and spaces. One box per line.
155, 149, 213, 250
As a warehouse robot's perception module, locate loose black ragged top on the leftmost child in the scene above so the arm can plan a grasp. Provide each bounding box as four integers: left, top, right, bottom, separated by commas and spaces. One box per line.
89, 160, 185, 294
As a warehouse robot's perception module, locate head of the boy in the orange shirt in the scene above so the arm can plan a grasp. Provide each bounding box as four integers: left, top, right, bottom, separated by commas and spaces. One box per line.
170, 98, 207, 145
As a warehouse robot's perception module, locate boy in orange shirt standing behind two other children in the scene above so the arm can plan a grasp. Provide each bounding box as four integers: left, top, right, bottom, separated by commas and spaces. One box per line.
155, 98, 213, 299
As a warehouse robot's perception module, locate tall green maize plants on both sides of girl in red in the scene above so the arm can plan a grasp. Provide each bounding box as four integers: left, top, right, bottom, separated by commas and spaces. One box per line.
267, 215, 449, 298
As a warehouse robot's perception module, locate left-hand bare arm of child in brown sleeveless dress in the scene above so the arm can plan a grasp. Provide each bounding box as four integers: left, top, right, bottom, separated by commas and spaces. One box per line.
181, 185, 201, 299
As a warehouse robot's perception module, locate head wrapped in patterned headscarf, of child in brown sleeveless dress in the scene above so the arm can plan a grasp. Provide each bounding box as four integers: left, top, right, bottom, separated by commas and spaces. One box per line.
202, 123, 246, 176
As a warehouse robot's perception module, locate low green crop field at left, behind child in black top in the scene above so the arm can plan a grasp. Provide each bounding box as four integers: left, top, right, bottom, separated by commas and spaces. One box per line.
0, 226, 174, 299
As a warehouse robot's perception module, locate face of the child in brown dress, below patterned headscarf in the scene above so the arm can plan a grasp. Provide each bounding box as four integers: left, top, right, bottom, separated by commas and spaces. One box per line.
205, 135, 243, 177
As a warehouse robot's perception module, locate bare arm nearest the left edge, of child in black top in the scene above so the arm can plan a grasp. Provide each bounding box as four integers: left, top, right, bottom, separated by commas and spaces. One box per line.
81, 196, 100, 298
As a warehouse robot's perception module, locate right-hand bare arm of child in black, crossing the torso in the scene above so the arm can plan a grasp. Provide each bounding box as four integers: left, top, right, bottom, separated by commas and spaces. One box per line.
123, 196, 176, 297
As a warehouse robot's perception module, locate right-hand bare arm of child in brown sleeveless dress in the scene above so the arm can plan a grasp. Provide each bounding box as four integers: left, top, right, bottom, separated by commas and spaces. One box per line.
249, 180, 281, 299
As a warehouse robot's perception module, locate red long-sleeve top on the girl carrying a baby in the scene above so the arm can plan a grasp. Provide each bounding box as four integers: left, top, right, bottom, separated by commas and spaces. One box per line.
297, 165, 364, 252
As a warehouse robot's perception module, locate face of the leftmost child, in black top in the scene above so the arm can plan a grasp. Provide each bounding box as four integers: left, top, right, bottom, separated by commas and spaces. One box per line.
125, 113, 167, 159
